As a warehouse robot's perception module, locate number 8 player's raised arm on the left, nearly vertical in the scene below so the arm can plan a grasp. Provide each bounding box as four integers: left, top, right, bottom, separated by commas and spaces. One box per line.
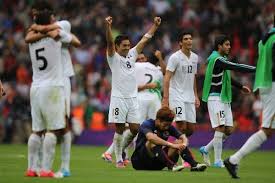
105, 16, 115, 57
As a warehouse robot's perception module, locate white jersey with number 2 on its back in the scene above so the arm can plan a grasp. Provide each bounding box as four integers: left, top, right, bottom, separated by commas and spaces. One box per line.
136, 62, 163, 97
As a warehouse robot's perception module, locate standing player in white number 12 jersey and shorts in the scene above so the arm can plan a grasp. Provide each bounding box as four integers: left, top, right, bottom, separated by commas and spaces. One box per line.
162, 31, 200, 137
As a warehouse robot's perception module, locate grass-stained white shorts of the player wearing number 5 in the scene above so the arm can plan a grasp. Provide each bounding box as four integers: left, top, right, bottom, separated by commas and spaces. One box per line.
30, 86, 65, 132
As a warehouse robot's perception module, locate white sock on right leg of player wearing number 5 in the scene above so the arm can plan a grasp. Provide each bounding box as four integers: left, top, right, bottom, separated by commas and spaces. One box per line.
42, 132, 56, 171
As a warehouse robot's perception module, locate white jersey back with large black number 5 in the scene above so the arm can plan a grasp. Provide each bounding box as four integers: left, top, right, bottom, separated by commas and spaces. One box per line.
29, 38, 64, 87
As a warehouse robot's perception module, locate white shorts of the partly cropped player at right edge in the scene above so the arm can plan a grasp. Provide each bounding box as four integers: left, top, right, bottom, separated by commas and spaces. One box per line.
260, 82, 275, 129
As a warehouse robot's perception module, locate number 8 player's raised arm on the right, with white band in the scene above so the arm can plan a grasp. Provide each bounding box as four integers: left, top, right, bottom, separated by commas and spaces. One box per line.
136, 17, 161, 53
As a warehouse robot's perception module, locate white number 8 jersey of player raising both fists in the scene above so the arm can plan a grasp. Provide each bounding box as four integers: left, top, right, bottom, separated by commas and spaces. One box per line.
107, 47, 138, 98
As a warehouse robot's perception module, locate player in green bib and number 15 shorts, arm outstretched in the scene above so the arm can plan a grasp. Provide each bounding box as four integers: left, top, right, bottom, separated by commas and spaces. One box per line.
200, 35, 255, 168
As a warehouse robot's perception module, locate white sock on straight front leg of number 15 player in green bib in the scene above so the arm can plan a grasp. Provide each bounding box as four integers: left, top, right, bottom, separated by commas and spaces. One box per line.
213, 131, 224, 162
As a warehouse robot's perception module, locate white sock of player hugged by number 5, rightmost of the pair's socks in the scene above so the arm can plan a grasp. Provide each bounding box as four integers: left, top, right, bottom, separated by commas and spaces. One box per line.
61, 131, 72, 171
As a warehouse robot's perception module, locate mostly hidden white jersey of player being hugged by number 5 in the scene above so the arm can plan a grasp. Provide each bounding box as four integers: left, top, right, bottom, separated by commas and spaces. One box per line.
56, 20, 75, 77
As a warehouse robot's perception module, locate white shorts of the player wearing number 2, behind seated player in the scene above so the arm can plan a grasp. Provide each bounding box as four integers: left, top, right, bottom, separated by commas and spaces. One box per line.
138, 93, 161, 123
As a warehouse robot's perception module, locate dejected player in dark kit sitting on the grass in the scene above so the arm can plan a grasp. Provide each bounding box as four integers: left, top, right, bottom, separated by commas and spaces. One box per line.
131, 107, 207, 171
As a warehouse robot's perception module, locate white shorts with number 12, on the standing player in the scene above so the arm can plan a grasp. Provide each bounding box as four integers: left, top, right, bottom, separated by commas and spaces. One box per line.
169, 100, 196, 123
